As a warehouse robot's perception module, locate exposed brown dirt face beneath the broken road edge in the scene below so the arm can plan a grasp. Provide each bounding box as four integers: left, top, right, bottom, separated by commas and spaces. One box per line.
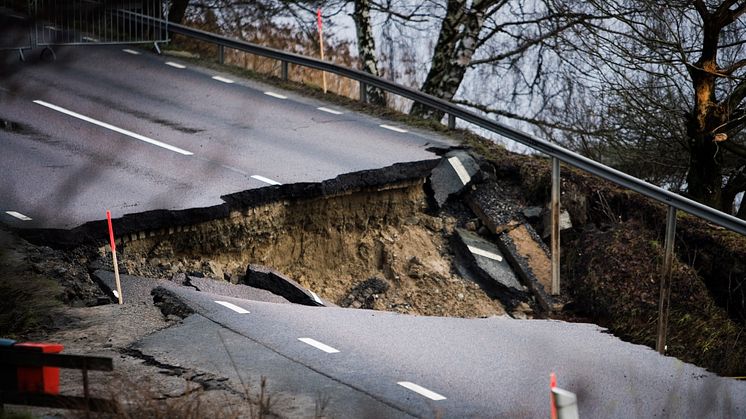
123, 182, 504, 317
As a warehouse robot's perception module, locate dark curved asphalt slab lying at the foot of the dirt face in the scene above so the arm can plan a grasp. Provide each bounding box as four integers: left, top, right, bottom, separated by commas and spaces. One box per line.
243, 264, 326, 306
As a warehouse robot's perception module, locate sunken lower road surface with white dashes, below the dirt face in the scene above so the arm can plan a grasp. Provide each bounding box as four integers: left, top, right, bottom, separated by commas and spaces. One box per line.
125, 283, 746, 418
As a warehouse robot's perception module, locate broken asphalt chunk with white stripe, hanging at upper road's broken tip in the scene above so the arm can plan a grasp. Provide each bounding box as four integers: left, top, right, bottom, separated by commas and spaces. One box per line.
430, 150, 479, 207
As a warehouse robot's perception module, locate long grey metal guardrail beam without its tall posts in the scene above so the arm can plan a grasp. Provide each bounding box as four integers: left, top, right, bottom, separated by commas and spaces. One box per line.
119, 11, 746, 235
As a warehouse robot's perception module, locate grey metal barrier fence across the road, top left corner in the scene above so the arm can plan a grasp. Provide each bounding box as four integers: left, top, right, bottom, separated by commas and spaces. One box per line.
0, 0, 168, 58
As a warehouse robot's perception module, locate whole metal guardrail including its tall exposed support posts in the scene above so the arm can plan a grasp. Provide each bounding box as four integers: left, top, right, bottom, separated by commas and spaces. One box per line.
123, 11, 746, 353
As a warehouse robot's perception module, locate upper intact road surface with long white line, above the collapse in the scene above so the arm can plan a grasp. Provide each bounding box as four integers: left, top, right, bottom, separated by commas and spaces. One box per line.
0, 46, 453, 228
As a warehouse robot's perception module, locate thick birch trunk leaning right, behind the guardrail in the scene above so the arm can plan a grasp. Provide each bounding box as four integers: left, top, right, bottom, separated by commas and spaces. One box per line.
410, 0, 486, 121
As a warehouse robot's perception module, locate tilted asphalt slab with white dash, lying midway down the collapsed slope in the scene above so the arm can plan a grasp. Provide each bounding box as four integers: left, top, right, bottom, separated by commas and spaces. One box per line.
455, 228, 529, 301
